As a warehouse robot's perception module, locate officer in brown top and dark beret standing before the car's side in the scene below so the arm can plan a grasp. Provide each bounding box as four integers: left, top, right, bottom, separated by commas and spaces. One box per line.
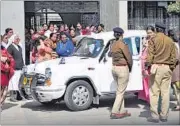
109, 27, 132, 119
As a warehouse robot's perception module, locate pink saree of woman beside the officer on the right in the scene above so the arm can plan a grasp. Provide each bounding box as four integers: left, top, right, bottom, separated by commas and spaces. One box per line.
138, 47, 149, 103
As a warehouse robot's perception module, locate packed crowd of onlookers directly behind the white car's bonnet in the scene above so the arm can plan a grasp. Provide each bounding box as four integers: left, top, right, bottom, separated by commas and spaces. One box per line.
26, 23, 104, 64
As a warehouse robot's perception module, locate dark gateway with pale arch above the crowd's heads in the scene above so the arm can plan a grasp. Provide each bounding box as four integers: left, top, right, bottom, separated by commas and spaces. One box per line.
25, 1, 100, 30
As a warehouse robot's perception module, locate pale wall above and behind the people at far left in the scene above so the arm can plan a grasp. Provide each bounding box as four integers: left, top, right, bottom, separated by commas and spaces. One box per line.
1, 1, 25, 60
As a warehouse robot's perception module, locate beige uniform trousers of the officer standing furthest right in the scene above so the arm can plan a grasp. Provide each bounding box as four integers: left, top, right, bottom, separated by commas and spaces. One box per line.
150, 65, 172, 119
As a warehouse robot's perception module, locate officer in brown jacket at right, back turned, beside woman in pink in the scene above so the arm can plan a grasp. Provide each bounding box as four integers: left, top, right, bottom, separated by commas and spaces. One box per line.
145, 23, 176, 123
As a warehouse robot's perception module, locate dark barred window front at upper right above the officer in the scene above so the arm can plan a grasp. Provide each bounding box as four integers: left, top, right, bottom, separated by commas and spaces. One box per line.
128, 1, 180, 31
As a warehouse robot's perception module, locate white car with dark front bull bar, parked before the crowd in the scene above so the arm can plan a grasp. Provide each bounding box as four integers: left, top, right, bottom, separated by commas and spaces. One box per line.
19, 30, 146, 111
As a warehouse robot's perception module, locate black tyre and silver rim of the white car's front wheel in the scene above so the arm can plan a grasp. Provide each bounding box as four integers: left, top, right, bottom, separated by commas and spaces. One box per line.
64, 80, 93, 111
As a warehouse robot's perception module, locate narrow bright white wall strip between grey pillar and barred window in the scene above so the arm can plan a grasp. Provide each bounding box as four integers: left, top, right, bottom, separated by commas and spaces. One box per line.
119, 1, 128, 30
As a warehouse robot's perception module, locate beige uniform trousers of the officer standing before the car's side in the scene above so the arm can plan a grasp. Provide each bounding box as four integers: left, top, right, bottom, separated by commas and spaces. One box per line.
112, 66, 129, 113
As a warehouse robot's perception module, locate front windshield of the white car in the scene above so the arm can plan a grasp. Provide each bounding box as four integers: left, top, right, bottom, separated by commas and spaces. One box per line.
73, 38, 104, 58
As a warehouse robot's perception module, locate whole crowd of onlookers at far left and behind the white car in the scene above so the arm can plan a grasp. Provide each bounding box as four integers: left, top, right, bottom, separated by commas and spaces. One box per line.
1, 23, 104, 110
